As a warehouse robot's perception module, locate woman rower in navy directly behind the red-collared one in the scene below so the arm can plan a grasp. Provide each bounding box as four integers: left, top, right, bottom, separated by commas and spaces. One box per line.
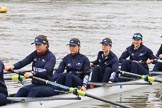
53, 38, 90, 91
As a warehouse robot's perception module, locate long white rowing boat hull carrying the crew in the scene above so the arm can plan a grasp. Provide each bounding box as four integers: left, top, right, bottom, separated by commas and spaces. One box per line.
1, 75, 159, 108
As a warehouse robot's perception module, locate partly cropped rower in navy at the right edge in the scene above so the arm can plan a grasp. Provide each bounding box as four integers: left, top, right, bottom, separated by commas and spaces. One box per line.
153, 36, 162, 71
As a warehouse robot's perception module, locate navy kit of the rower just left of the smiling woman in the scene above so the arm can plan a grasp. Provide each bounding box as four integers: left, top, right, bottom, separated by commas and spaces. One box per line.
91, 51, 119, 82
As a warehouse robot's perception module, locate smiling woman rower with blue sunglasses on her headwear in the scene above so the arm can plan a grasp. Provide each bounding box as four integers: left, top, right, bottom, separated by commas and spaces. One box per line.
119, 33, 156, 75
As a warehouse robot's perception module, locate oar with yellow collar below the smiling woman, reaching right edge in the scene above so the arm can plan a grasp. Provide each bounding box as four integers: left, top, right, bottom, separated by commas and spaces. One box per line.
119, 71, 162, 83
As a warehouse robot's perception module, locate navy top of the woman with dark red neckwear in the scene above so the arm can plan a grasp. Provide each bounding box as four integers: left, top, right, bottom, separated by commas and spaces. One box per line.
14, 50, 56, 84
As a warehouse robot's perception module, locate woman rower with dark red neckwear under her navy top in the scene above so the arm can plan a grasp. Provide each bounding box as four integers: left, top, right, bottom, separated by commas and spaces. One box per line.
5, 35, 56, 97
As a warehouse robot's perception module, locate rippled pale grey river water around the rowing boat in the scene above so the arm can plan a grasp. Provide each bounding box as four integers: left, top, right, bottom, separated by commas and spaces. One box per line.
0, 0, 162, 108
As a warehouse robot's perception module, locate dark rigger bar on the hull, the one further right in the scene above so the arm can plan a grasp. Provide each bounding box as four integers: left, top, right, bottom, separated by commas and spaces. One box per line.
88, 82, 152, 87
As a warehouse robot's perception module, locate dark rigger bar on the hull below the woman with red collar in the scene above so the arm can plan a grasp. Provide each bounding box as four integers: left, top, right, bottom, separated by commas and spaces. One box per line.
7, 96, 81, 103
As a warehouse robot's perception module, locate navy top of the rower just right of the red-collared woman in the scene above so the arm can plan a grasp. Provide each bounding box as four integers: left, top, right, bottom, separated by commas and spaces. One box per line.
56, 53, 90, 79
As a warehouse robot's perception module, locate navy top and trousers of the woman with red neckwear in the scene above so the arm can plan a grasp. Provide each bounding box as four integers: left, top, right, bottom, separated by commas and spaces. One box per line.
14, 50, 56, 97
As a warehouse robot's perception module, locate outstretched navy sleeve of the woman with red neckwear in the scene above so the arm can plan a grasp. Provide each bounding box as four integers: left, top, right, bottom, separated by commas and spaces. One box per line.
14, 51, 35, 69
